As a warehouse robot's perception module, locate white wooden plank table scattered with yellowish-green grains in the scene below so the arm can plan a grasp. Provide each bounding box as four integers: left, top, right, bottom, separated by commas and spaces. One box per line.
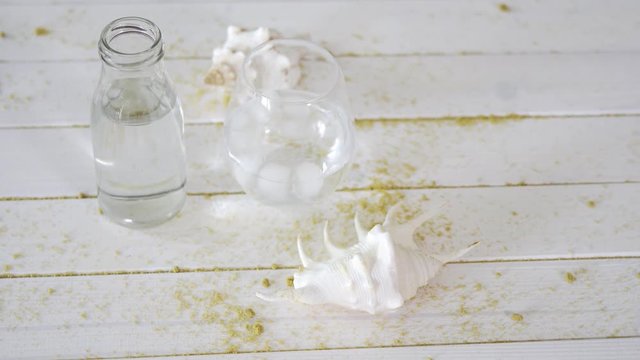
0, 0, 640, 359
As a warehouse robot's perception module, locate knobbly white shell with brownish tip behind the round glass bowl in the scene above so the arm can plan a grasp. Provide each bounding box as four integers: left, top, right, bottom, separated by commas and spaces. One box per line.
204, 26, 300, 87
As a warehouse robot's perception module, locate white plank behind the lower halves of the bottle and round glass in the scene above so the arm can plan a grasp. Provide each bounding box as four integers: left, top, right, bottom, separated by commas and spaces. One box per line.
0, 116, 640, 197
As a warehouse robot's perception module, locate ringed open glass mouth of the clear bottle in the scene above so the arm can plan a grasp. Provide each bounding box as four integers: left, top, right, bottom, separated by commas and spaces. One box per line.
98, 16, 164, 68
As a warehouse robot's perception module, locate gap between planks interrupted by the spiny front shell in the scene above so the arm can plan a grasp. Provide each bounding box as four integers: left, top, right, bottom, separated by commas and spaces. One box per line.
0, 255, 640, 282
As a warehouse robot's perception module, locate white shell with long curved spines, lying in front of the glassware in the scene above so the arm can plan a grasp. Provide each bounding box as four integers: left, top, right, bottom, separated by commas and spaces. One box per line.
256, 204, 477, 314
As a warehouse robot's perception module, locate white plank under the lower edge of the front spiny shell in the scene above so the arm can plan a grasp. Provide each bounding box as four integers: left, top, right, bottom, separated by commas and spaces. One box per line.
0, 259, 640, 358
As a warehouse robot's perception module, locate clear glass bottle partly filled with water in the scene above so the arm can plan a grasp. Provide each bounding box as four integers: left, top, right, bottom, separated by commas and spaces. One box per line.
91, 17, 186, 228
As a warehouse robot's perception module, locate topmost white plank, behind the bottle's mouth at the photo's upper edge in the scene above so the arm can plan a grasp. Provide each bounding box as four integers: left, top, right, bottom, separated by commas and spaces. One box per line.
0, 0, 639, 61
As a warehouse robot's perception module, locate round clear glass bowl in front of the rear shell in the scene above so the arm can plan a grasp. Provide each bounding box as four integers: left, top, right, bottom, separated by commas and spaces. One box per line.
225, 39, 355, 205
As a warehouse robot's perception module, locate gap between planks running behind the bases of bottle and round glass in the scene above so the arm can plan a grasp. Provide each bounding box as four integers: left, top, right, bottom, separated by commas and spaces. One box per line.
0, 180, 640, 201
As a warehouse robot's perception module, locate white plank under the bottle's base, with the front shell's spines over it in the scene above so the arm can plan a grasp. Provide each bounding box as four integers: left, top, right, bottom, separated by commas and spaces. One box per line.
0, 184, 640, 277
